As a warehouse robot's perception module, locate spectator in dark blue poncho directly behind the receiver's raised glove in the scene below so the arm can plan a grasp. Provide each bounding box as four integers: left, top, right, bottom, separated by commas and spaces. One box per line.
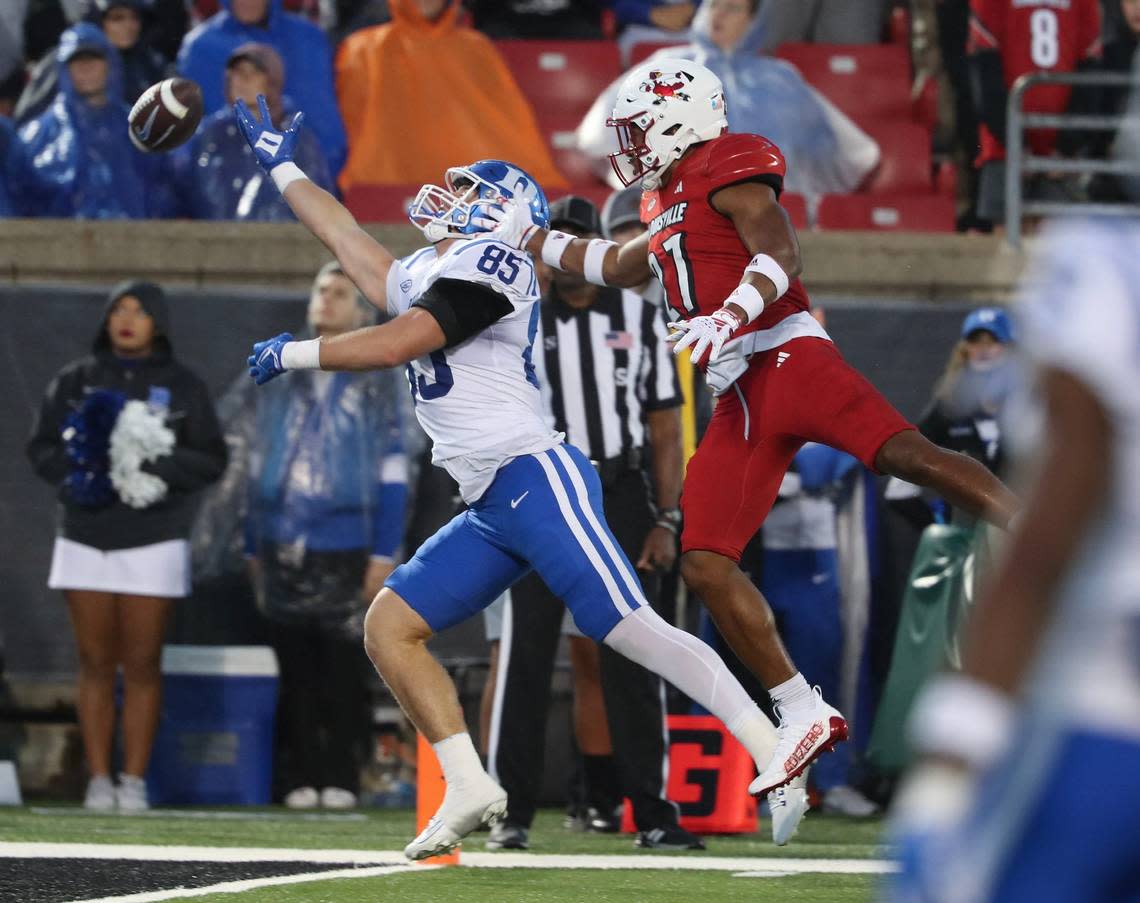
172, 43, 333, 222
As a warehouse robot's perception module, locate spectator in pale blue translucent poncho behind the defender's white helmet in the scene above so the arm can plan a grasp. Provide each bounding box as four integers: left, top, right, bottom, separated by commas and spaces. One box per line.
578, 0, 879, 196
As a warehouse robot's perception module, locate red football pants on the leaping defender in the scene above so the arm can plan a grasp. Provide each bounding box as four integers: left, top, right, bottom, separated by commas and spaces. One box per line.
681, 337, 914, 561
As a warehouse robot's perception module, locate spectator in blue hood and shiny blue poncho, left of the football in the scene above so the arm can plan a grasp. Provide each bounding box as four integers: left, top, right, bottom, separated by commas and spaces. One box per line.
19, 22, 169, 219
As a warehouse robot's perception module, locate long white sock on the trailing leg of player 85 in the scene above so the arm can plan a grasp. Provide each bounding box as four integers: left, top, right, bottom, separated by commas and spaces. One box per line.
605, 605, 776, 766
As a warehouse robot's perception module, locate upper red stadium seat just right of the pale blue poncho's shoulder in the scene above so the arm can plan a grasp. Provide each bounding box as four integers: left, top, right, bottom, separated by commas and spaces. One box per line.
775, 43, 912, 125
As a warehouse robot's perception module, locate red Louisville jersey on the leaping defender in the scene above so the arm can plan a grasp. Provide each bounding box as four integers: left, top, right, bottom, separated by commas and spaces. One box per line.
641, 135, 811, 335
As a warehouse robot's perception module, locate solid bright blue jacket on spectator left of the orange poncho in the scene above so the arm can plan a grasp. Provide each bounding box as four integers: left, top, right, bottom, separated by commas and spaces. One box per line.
178, 0, 345, 174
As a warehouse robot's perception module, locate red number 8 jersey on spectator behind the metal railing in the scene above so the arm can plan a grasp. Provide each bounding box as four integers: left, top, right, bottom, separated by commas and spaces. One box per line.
969, 0, 1100, 163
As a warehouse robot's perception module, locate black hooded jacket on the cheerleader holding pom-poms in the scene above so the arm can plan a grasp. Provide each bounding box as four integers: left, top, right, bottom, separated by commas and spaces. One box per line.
27, 282, 227, 551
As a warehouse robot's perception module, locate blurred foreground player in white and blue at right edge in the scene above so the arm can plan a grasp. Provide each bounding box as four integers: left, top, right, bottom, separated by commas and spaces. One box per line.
887, 220, 1140, 903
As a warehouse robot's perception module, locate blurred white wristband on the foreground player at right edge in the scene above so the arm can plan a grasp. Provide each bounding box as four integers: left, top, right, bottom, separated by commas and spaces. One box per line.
909, 675, 1015, 768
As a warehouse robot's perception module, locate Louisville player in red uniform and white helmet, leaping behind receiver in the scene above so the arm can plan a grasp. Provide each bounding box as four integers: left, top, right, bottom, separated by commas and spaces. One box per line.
478, 59, 1016, 794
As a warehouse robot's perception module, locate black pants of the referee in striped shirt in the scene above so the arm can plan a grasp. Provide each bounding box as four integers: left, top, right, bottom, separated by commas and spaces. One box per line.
488, 470, 677, 831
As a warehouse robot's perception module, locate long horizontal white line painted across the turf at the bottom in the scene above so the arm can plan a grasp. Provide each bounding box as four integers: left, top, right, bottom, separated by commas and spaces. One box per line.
0, 843, 896, 871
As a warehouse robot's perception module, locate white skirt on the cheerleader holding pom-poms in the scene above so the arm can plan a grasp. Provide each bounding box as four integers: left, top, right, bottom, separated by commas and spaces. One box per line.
48, 536, 190, 599
